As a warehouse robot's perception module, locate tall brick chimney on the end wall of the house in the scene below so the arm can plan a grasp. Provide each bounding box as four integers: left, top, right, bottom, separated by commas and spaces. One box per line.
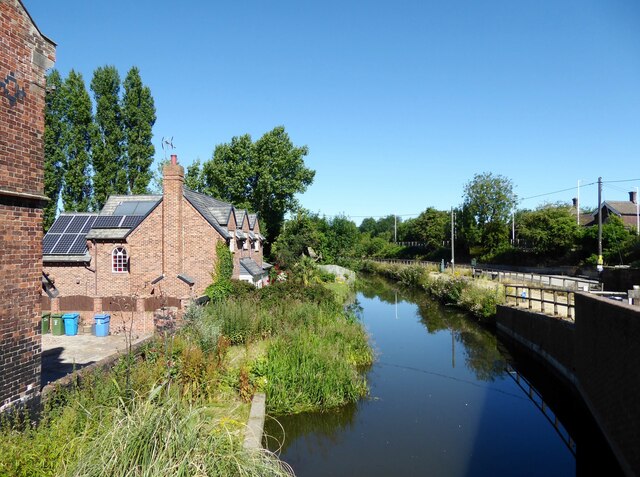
162, 154, 184, 277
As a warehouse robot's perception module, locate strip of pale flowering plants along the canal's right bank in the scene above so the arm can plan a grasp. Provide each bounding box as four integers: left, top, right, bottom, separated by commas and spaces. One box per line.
362, 261, 504, 322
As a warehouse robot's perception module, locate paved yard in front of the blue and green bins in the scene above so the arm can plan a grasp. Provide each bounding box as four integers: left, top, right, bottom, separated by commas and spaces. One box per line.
41, 333, 150, 386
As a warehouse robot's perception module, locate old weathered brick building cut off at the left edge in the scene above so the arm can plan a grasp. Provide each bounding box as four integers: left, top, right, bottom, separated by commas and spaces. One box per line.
0, 0, 55, 411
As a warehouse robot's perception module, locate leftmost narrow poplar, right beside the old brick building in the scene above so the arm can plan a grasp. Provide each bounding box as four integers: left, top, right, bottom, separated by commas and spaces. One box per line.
43, 70, 67, 231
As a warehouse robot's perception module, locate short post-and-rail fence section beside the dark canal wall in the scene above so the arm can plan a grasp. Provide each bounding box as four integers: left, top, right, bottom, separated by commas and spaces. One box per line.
504, 283, 576, 321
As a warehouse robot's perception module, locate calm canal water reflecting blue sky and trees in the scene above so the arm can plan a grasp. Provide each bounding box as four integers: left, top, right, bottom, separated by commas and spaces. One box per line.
265, 278, 616, 477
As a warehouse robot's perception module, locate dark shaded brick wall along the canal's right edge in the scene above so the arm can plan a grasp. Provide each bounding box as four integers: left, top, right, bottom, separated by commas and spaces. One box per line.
496, 293, 640, 475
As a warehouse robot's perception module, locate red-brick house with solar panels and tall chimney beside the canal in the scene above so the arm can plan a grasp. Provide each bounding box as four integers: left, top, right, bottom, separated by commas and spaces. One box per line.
43, 155, 270, 331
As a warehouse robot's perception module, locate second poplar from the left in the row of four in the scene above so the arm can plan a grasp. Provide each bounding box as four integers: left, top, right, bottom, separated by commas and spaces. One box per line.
62, 70, 93, 212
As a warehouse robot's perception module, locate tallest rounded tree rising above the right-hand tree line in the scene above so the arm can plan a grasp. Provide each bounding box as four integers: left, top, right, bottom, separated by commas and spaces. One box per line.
462, 172, 517, 251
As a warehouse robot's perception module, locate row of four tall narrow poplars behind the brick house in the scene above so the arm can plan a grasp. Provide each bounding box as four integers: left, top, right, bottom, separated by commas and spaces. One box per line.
43, 66, 156, 230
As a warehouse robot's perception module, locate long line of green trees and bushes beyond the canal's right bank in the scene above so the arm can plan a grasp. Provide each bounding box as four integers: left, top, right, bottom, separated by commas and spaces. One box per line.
273, 173, 640, 267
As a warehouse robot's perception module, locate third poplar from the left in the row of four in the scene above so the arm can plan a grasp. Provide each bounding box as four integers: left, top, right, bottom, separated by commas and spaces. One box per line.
91, 66, 128, 210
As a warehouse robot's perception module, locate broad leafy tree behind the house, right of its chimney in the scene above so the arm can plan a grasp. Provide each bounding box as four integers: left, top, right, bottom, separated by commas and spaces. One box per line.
202, 126, 315, 241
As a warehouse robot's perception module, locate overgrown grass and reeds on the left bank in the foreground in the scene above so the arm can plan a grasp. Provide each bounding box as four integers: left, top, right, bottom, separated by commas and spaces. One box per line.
0, 280, 373, 476
